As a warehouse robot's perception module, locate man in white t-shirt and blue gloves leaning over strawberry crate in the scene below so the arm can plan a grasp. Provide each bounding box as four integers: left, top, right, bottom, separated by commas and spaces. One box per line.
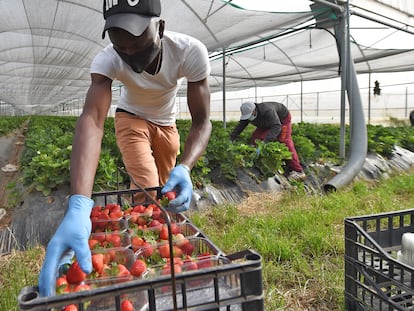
39, 0, 212, 296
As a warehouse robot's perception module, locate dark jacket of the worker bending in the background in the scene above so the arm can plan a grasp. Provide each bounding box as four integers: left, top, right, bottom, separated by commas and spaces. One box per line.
230, 102, 289, 142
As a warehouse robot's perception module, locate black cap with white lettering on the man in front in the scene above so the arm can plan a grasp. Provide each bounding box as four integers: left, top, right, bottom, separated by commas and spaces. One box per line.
102, 0, 161, 39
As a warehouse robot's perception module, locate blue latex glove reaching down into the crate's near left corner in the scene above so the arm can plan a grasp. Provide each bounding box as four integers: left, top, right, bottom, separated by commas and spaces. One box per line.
39, 195, 93, 297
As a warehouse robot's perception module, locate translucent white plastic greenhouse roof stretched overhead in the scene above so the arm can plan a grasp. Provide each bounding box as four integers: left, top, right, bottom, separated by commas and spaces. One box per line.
0, 0, 414, 113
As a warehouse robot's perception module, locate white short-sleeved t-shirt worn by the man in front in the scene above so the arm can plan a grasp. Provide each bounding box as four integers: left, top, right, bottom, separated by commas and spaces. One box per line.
90, 31, 211, 126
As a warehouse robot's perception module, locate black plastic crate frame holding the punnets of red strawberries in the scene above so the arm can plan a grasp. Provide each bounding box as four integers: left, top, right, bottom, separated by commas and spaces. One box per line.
18, 187, 264, 311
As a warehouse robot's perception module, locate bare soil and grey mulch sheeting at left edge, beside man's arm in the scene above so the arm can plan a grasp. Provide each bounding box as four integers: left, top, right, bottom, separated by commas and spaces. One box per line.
0, 125, 69, 254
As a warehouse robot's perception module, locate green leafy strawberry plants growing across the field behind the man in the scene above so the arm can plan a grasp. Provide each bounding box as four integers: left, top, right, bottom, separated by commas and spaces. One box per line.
0, 116, 414, 199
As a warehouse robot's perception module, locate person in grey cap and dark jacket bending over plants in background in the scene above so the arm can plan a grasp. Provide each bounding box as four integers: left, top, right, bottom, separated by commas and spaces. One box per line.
230, 102, 306, 180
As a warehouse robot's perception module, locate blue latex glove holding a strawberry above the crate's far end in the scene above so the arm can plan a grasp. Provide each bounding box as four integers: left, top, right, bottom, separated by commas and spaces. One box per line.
161, 164, 193, 213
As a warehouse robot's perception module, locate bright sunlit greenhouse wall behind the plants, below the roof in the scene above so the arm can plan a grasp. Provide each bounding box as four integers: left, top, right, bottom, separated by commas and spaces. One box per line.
0, 78, 414, 125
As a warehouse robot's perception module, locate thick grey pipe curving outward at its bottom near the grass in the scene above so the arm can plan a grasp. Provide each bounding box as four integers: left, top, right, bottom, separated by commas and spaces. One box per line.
324, 3, 368, 192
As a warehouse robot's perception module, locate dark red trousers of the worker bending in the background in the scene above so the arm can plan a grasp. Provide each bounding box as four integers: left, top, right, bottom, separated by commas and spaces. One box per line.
252, 113, 303, 172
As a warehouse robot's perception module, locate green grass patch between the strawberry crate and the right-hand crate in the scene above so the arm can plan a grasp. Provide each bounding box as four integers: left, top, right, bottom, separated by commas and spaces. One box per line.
190, 174, 414, 311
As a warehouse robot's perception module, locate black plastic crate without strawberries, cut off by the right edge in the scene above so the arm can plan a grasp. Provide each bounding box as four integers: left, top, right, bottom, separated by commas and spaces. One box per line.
345, 209, 414, 311
